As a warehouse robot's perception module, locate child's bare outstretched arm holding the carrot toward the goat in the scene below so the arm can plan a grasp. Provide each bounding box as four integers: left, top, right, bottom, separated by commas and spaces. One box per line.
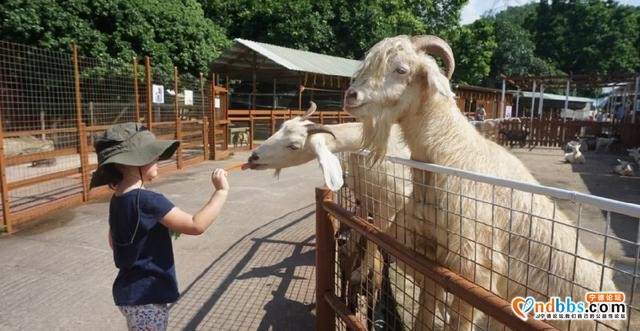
160, 169, 229, 235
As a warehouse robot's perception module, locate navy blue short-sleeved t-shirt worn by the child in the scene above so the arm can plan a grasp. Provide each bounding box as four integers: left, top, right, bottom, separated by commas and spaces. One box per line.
109, 189, 178, 306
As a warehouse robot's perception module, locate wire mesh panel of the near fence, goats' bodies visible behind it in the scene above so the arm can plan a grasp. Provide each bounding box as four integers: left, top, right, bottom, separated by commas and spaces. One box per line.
336, 154, 640, 330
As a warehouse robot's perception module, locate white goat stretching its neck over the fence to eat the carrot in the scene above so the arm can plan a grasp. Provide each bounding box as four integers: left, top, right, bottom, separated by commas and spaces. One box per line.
242, 103, 411, 324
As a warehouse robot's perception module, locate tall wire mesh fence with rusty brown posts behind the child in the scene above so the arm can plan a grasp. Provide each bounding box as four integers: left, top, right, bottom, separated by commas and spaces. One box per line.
0, 41, 219, 232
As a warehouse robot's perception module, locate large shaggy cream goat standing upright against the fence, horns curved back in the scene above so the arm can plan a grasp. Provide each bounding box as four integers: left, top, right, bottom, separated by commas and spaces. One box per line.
345, 36, 619, 330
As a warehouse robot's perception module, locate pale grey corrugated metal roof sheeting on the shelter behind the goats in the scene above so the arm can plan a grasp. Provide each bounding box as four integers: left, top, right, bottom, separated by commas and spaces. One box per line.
214, 38, 360, 77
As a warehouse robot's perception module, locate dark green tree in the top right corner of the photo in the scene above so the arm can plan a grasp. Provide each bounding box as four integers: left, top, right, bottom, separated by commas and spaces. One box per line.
532, 0, 640, 74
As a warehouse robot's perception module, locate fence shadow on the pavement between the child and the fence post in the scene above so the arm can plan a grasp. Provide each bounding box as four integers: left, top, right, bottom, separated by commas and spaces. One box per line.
170, 205, 315, 330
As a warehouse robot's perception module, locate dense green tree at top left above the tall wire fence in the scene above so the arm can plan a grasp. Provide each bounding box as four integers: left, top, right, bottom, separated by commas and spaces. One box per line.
0, 0, 229, 74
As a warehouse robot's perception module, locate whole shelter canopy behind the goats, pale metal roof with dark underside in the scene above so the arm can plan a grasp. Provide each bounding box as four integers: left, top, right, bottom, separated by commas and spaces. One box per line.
211, 38, 361, 82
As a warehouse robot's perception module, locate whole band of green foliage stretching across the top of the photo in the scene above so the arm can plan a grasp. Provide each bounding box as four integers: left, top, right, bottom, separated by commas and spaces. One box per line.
0, 0, 640, 86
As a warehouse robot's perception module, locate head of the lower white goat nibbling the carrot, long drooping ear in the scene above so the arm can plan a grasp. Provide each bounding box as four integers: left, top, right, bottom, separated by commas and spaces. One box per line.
248, 102, 343, 191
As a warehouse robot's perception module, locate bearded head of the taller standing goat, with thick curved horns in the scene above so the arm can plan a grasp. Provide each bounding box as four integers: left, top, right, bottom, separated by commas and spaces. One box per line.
344, 36, 455, 159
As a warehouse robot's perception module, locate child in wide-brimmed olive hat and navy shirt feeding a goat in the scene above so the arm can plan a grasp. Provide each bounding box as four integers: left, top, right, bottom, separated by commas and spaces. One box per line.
91, 123, 229, 330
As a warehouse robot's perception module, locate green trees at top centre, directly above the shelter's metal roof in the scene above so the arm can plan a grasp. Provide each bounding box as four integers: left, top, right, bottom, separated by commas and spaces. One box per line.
201, 0, 467, 59
